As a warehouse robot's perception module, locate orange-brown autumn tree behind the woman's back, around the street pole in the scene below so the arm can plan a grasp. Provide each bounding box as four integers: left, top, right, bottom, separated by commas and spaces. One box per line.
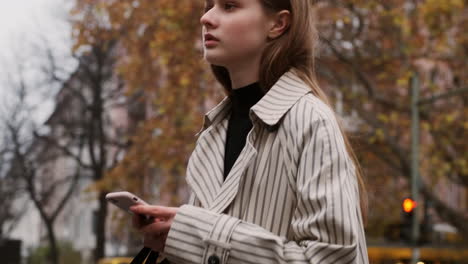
317, 0, 468, 237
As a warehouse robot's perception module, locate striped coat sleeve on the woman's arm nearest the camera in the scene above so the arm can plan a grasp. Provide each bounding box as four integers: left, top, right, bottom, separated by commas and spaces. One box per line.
165, 120, 368, 264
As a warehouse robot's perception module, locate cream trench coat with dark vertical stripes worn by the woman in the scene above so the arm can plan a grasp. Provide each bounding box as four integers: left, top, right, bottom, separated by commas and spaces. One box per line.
164, 71, 368, 264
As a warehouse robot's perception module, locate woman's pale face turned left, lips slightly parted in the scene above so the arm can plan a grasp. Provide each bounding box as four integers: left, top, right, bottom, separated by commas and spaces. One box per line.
200, 0, 272, 69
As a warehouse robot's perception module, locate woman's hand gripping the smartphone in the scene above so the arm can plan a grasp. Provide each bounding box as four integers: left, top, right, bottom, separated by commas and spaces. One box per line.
130, 205, 179, 252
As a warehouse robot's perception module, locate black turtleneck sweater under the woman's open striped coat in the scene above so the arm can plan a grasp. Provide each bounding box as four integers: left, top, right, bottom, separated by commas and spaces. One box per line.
224, 82, 264, 179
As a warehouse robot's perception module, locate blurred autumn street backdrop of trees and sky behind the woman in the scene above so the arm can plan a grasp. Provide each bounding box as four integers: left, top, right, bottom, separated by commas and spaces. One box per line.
0, 0, 468, 264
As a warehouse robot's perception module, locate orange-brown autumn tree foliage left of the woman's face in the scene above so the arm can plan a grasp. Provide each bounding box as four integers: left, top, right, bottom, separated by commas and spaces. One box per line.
74, 0, 221, 205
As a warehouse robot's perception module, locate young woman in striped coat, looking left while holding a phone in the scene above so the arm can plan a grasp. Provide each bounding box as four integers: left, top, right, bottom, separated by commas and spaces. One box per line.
132, 0, 368, 264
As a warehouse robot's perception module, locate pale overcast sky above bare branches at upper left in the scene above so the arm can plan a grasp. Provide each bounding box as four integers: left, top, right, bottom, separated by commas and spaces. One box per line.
0, 0, 73, 122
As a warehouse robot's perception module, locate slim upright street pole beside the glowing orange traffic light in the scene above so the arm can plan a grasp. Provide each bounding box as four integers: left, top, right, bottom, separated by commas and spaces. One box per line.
411, 72, 420, 264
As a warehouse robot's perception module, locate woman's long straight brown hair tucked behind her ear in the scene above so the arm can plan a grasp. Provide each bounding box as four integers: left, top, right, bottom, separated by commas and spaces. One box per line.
207, 0, 367, 222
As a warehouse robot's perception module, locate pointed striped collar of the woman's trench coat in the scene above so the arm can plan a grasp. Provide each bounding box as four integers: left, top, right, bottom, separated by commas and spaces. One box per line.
202, 70, 311, 130
